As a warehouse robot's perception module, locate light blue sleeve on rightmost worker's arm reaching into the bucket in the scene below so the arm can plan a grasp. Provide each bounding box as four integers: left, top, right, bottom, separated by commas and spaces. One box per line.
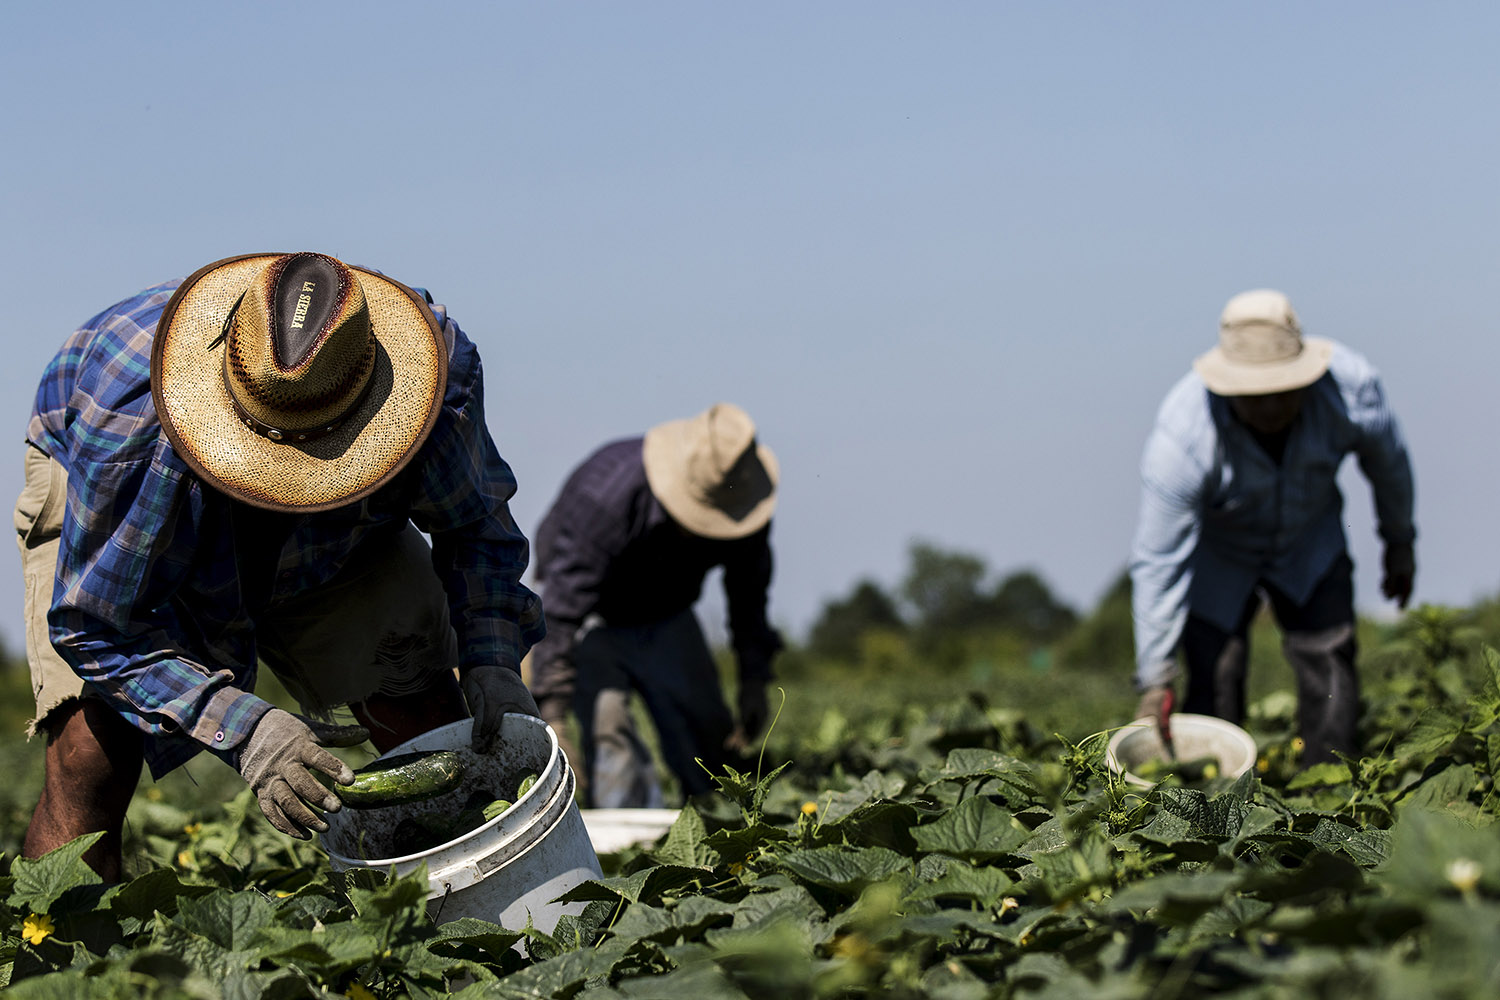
1130, 426, 1205, 690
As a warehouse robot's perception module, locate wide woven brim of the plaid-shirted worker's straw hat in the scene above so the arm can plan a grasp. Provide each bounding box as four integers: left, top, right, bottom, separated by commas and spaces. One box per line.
152, 253, 447, 513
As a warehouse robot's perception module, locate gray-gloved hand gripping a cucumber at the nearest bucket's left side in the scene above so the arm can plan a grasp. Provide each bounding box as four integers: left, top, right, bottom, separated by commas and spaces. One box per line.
234, 708, 354, 840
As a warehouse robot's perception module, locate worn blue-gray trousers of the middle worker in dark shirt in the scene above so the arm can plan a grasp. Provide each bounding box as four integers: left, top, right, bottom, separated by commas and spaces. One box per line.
573, 609, 735, 808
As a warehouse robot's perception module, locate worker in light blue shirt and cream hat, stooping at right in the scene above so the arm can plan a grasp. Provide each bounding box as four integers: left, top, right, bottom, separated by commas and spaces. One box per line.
1131, 291, 1416, 763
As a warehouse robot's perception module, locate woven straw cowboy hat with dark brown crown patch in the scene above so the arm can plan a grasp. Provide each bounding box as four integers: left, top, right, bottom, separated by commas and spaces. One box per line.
152, 252, 449, 511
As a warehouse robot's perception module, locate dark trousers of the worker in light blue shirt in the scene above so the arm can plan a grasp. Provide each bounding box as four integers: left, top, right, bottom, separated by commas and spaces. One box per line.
1182, 555, 1359, 765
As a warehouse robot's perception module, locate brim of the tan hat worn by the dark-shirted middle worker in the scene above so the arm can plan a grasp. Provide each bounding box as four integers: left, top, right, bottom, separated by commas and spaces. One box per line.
641, 420, 782, 540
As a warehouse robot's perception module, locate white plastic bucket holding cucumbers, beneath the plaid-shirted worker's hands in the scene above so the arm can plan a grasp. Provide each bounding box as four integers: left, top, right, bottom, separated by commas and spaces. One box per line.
321, 714, 603, 933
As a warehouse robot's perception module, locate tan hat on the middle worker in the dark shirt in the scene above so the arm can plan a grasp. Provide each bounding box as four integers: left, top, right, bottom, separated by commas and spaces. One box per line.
642, 403, 780, 538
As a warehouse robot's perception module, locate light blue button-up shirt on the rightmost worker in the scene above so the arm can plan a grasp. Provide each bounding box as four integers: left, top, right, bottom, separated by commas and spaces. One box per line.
1130, 343, 1416, 688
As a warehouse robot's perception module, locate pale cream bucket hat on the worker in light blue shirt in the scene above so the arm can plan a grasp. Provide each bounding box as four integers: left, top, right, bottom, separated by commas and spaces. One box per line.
1193, 288, 1334, 396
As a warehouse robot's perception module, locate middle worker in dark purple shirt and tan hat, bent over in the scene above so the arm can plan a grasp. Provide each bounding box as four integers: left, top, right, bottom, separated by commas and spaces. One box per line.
531, 403, 782, 808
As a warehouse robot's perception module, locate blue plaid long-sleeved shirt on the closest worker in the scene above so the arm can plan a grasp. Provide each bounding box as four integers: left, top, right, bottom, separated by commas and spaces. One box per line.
27, 279, 545, 777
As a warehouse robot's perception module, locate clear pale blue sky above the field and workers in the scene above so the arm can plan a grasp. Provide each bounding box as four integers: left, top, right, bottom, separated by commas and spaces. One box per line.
0, 0, 1500, 648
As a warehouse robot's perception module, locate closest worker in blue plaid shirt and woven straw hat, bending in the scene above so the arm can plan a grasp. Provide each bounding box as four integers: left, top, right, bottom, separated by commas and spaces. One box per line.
15, 253, 543, 880
